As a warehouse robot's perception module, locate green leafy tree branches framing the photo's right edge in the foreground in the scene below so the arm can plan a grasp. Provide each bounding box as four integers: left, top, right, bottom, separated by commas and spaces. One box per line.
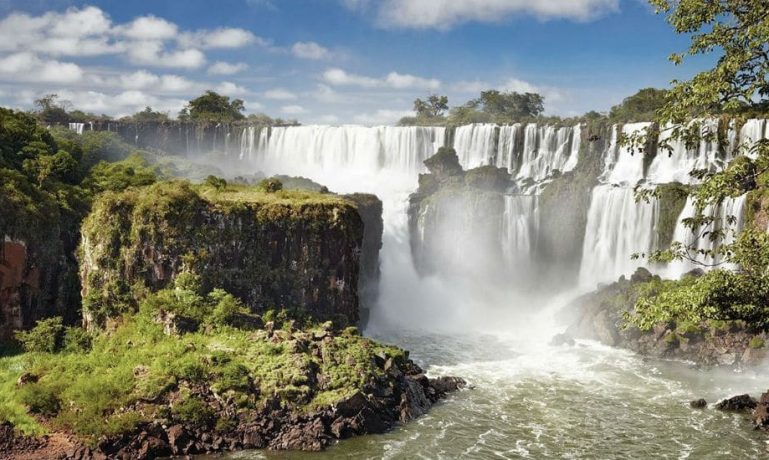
636, 0, 769, 329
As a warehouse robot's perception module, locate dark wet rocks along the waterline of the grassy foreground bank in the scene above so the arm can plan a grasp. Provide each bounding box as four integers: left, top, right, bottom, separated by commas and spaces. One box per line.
9, 348, 466, 460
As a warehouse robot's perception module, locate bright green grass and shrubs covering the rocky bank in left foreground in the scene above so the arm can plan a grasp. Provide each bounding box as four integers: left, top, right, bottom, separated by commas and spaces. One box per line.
0, 278, 405, 443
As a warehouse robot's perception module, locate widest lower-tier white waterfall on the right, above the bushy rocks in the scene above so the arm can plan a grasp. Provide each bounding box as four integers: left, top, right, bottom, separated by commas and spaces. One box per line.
579, 184, 659, 288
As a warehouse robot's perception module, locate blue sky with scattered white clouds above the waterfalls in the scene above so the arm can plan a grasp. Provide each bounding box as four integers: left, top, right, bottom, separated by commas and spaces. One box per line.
0, 0, 712, 125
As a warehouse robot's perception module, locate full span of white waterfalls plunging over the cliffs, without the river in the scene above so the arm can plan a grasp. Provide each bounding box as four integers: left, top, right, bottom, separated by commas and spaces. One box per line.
220, 120, 769, 316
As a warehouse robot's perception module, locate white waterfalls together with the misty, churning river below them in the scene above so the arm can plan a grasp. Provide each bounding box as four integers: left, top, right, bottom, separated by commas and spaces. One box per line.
218, 119, 765, 458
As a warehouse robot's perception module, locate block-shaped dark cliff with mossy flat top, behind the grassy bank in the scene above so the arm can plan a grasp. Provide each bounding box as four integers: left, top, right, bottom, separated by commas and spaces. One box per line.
80, 182, 381, 327
